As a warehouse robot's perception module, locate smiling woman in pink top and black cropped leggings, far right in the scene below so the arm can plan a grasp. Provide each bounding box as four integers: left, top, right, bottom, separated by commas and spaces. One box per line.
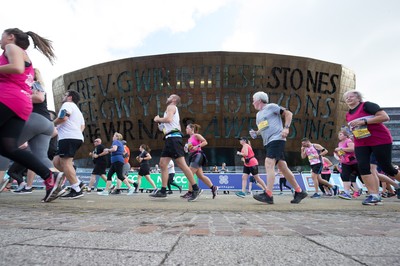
343, 90, 400, 205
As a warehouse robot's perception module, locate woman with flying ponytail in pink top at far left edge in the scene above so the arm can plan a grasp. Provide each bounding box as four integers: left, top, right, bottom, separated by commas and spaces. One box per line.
0, 28, 62, 202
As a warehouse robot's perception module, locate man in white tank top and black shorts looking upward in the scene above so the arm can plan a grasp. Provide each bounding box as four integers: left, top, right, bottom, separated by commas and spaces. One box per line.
150, 94, 202, 201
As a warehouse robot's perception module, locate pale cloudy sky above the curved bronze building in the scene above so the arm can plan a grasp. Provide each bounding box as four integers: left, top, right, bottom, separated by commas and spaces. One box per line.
0, 0, 400, 109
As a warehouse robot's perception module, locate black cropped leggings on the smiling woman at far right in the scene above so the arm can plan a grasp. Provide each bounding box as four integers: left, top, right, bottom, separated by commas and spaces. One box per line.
354, 144, 398, 176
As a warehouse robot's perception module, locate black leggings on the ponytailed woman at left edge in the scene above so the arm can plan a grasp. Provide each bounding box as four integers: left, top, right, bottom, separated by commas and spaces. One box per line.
0, 103, 50, 179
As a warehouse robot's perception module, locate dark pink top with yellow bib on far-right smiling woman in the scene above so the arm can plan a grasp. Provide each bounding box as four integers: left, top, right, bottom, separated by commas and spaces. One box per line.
346, 102, 393, 147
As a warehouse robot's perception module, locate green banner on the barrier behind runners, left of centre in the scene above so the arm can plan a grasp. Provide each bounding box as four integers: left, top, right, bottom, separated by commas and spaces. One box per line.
97, 172, 197, 190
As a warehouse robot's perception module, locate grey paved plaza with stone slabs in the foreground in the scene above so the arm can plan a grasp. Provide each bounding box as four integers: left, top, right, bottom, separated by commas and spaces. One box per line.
0, 190, 400, 265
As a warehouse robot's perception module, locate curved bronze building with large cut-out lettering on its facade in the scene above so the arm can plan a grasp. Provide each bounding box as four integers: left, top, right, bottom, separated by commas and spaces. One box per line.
53, 52, 355, 166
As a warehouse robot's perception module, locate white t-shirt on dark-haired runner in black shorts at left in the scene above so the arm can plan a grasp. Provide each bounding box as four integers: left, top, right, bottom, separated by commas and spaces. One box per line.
57, 102, 85, 141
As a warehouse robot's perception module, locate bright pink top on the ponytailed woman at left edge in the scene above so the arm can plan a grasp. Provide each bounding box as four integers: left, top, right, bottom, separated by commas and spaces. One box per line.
0, 53, 34, 121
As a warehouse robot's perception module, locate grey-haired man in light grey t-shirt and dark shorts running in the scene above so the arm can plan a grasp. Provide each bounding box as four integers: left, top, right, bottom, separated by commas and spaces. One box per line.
249, 91, 307, 204
